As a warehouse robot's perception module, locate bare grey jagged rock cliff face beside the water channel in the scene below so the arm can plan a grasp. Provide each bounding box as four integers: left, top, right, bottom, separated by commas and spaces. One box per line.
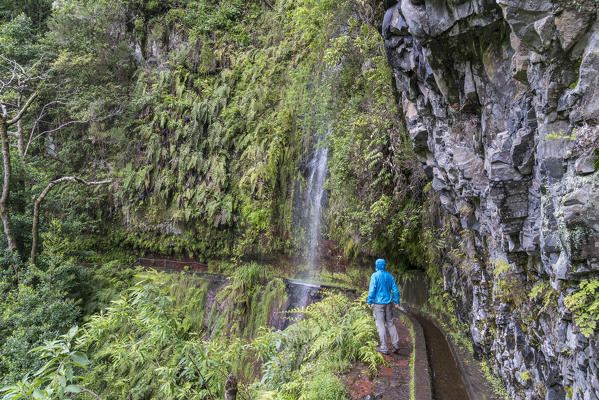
383, 0, 599, 400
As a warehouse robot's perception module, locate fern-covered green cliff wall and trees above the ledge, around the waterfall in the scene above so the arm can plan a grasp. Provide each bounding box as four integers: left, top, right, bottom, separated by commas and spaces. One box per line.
0, 0, 424, 265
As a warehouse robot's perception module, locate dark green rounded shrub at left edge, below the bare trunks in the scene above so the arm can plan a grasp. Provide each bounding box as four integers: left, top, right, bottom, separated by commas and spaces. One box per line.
0, 253, 86, 384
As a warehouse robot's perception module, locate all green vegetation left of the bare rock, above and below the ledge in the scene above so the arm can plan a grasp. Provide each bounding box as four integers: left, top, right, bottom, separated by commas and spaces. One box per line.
0, 0, 440, 399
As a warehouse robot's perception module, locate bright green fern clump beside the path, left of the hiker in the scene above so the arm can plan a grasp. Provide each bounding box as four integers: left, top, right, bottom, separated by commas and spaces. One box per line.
252, 293, 384, 398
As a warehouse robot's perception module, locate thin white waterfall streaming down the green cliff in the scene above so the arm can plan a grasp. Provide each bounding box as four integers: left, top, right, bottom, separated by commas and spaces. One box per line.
304, 131, 329, 278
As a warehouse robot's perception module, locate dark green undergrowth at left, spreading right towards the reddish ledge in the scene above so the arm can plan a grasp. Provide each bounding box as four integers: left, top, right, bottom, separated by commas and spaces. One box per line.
0, 222, 134, 385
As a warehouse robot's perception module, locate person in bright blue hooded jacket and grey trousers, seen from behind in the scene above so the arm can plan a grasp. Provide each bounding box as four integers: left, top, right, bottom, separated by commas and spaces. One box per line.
366, 259, 399, 354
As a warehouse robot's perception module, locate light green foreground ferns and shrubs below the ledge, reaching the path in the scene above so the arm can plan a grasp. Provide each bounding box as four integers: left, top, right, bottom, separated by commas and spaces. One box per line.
4, 265, 383, 399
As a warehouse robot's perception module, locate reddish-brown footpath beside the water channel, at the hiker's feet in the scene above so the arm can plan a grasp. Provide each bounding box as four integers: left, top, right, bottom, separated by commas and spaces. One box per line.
345, 318, 412, 400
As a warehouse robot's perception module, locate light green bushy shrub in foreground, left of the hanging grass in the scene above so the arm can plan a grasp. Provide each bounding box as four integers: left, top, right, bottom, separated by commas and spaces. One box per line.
81, 272, 219, 399
